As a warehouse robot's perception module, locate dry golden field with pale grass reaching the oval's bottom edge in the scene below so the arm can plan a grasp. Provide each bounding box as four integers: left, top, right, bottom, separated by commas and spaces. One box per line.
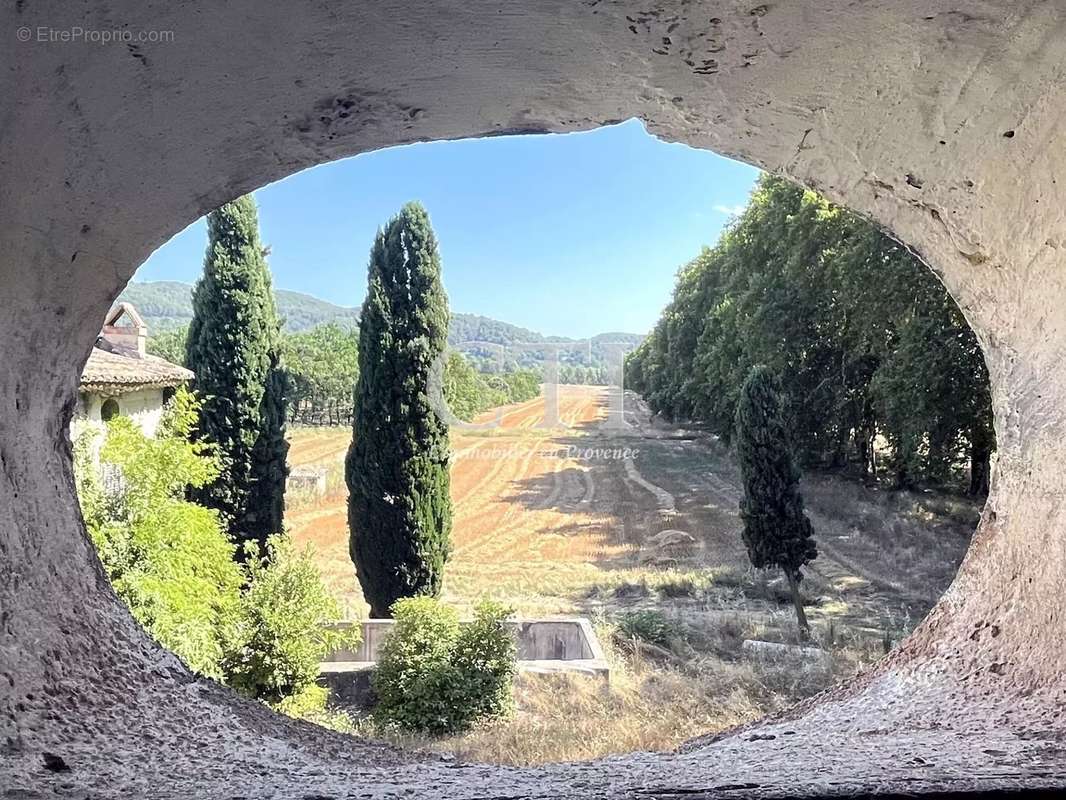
287, 386, 979, 764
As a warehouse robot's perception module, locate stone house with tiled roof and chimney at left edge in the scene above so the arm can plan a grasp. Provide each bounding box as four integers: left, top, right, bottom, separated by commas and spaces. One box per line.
76, 303, 194, 436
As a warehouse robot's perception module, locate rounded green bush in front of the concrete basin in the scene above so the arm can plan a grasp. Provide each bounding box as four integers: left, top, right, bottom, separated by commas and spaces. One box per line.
372, 597, 517, 735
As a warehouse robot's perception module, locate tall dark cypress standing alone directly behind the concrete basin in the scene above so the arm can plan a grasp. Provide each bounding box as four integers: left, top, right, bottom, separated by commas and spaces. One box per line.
344, 203, 452, 618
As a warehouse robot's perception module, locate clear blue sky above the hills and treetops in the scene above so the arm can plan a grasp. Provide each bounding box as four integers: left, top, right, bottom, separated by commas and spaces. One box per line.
134, 121, 758, 337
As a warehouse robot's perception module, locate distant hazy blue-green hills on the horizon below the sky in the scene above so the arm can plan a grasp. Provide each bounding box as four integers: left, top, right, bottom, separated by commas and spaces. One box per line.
119, 281, 644, 371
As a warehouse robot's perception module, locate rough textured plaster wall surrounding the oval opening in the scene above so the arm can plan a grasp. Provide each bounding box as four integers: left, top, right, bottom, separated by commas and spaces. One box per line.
0, 0, 1066, 798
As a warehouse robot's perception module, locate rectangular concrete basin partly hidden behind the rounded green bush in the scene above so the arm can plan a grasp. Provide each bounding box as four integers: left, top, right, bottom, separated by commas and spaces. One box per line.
319, 617, 611, 708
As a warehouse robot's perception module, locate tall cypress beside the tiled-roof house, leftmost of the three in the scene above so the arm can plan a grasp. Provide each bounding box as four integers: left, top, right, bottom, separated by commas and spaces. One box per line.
185, 195, 287, 547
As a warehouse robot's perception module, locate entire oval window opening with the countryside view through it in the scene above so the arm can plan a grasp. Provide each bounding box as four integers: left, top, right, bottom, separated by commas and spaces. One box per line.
78, 121, 995, 765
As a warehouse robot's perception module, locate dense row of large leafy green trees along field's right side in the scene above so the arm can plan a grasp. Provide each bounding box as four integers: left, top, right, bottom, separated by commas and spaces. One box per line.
626, 176, 995, 494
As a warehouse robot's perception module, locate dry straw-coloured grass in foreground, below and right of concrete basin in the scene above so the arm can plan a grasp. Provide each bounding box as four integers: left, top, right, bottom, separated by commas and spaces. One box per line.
362, 625, 882, 766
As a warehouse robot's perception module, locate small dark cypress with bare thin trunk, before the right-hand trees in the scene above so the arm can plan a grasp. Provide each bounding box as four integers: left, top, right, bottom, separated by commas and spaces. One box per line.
737, 366, 818, 639
